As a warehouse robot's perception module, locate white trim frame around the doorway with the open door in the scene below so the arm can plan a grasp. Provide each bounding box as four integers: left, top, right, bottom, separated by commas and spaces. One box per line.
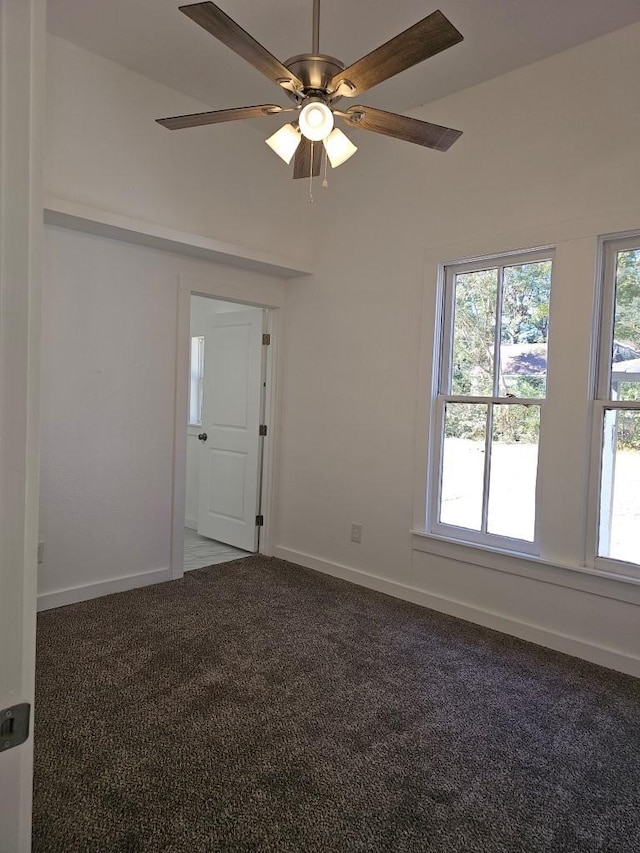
171, 276, 282, 580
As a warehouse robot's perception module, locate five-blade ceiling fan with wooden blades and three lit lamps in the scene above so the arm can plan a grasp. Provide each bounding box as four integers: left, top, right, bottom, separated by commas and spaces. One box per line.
157, 0, 462, 178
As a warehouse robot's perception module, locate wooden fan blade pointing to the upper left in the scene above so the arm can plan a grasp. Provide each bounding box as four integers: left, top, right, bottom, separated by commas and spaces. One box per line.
180, 3, 302, 91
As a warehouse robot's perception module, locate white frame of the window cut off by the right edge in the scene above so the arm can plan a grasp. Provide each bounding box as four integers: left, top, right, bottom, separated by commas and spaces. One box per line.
586, 232, 640, 578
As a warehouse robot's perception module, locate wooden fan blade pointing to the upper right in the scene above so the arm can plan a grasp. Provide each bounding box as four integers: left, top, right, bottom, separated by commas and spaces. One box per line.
330, 11, 463, 97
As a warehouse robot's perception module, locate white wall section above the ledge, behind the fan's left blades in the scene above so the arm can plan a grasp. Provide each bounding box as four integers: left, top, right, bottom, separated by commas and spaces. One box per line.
45, 35, 322, 259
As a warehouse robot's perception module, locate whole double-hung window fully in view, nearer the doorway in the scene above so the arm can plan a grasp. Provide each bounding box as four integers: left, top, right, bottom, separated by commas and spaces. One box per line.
429, 251, 552, 552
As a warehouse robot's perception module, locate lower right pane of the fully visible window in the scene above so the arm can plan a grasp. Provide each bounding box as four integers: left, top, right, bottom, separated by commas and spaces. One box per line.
487, 405, 540, 542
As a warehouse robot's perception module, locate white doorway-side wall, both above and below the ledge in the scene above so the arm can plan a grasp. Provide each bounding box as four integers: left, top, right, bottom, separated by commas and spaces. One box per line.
39, 31, 302, 606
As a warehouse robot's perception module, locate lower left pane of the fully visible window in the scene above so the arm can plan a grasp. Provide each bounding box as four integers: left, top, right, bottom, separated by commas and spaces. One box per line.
440, 403, 487, 530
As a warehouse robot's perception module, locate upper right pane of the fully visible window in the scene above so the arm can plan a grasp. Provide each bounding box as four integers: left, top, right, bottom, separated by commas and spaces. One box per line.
499, 261, 551, 398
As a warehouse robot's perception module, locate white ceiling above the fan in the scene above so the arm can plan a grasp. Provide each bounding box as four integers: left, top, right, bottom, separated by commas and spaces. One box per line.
48, 0, 640, 114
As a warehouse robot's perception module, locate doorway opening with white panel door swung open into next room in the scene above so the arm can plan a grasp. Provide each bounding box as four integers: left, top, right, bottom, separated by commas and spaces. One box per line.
183, 293, 269, 571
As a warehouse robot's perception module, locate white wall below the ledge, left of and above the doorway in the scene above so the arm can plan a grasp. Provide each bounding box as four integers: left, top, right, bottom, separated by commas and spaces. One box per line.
39, 226, 285, 606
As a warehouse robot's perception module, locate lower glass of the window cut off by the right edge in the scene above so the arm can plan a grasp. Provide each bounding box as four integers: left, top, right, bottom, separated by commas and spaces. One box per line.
598, 409, 640, 563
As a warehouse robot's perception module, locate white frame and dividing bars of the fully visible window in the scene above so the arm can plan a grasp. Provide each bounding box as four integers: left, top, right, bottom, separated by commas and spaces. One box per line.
426, 248, 555, 555
